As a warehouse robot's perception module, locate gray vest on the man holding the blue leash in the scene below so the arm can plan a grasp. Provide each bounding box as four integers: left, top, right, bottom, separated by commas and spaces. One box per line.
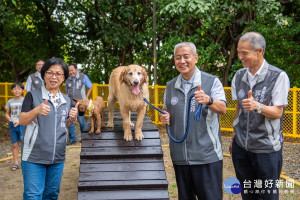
165, 69, 223, 165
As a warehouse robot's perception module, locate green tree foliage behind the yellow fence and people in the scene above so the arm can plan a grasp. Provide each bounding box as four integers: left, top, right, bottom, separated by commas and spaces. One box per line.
0, 0, 300, 87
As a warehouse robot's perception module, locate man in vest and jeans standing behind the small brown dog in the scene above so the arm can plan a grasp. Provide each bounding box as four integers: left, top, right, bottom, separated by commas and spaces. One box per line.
66, 64, 93, 145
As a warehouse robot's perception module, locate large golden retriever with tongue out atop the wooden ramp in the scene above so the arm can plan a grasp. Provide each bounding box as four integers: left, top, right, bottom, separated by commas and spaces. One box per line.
107, 65, 149, 141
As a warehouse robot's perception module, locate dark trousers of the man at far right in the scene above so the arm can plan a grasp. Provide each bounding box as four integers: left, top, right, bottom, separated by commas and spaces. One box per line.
232, 140, 282, 200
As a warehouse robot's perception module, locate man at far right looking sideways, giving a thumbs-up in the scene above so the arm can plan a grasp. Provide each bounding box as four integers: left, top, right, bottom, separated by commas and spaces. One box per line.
229, 32, 290, 200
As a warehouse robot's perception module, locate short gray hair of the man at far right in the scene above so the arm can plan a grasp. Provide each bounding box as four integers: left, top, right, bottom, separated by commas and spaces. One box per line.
239, 32, 266, 55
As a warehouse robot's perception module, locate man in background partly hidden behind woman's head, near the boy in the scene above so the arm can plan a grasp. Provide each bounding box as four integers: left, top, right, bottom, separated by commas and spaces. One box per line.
25, 59, 45, 92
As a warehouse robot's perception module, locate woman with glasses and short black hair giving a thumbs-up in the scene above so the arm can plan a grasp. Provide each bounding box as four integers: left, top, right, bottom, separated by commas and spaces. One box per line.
20, 58, 78, 200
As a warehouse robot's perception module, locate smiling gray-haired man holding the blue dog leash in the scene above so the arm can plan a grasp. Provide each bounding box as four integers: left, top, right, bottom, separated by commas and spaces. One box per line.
160, 42, 226, 200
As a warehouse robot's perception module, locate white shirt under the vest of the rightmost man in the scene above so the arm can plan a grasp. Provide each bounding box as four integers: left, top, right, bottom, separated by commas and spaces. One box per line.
231, 60, 290, 106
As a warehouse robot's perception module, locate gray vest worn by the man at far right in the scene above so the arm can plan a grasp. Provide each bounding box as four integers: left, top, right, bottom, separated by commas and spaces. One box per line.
233, 62, 283, 153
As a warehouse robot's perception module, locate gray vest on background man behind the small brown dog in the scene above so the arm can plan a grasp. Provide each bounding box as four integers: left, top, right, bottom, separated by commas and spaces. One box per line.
66, 72, 86, 106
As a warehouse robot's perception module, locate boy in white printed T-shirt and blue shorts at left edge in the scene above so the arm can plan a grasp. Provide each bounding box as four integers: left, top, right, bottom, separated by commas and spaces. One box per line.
5, 82, 24, 171
